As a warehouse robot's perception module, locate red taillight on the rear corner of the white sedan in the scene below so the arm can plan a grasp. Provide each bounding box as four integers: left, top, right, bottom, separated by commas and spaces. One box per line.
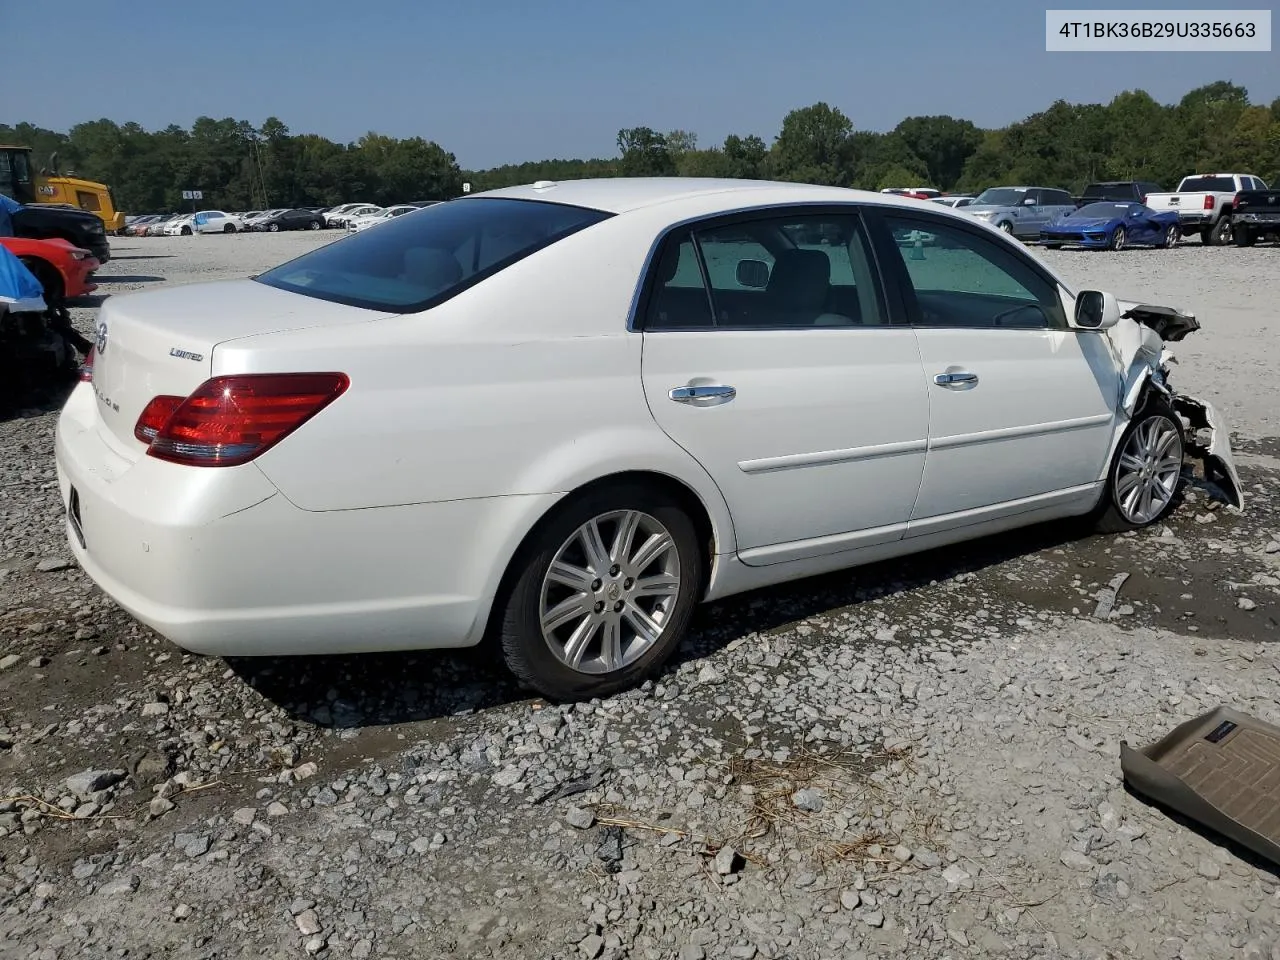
134, 374, 351, 467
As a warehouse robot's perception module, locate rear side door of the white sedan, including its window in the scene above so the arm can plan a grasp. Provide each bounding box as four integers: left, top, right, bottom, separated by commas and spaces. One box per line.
637, 206, 929, 564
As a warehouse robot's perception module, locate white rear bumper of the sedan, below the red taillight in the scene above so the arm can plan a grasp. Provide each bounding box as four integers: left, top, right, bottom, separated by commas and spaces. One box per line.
55, 384, 556, 657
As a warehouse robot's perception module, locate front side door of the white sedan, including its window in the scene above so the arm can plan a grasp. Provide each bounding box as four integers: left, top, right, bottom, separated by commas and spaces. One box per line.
876, 210, 1120, 536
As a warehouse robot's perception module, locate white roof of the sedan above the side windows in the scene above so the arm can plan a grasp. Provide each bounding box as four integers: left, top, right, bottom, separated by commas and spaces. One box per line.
465, 177, 947, 214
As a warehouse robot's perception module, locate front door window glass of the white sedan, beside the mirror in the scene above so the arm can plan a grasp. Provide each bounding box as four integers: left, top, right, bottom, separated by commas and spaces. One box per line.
884, 216, 1066, 329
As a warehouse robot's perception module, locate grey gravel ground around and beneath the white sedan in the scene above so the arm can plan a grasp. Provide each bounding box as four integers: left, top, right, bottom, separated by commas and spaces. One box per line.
0, 234, 1280, 960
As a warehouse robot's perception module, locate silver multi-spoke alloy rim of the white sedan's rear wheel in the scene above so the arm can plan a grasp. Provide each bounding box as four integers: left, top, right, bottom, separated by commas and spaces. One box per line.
538, 509, 681, 673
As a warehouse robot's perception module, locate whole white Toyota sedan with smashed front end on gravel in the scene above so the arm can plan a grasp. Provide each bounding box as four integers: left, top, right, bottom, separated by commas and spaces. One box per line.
56, 179, 1240, 699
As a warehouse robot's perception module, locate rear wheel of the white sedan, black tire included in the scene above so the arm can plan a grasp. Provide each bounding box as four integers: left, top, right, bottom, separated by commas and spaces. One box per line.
495, 484, 704, 700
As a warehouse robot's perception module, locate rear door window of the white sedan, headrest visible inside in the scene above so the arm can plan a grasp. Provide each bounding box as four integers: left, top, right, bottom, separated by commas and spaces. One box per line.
644, 214, 886, 330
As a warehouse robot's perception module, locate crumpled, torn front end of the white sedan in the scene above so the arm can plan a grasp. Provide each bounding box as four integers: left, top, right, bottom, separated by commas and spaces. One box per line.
1108, 303, 1244, 509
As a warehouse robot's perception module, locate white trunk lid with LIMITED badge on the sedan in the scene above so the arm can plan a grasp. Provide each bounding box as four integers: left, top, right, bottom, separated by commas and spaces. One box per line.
91, 280, 384, 456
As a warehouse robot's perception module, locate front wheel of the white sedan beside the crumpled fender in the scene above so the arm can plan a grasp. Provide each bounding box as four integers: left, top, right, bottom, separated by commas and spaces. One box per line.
1096, 401, 1184, 534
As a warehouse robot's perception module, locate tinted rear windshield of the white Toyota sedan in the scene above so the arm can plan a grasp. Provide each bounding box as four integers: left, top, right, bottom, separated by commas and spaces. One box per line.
256, 197, 612, 314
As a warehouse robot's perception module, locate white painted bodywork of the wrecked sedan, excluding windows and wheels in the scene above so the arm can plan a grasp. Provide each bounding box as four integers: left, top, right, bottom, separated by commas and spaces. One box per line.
56, 179, 1225, 654
